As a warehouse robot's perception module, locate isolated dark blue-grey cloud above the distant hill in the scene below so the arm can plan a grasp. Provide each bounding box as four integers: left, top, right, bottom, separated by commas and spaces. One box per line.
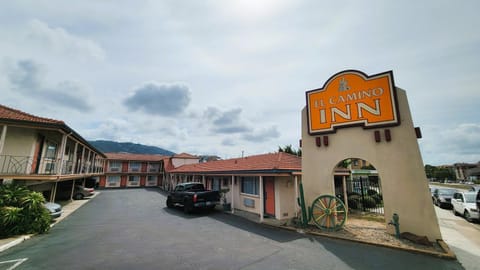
123, 82, 190, 116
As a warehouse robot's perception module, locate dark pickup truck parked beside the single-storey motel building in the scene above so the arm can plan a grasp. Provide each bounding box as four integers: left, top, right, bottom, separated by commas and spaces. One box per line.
167, 182, 220, 214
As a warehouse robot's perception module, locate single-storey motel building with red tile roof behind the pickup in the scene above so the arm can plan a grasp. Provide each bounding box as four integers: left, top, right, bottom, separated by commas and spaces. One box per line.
168, 152, 302, 221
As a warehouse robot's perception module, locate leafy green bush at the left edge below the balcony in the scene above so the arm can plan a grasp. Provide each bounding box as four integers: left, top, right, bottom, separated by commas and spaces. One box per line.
0, 184, 51, 237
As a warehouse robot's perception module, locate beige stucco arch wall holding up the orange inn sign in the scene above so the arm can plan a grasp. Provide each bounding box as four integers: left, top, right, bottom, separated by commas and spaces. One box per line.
302, 88, 442, 241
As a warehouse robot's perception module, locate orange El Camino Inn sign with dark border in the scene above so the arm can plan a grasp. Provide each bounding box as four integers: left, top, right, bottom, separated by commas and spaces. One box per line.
306, 70, 400, 134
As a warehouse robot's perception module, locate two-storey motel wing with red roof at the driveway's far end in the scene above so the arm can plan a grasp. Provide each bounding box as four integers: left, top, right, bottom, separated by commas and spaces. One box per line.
99, 153, 165, 188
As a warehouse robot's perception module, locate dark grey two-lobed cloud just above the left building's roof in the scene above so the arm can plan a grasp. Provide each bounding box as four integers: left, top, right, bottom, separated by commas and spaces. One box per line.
7, 59, 92, 112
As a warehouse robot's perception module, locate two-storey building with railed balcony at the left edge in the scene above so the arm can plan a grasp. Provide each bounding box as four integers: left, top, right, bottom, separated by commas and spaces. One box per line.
0, 105, 106, 201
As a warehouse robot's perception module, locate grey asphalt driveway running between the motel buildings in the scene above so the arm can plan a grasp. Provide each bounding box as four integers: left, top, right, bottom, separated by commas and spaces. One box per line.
0, 189, 463, 270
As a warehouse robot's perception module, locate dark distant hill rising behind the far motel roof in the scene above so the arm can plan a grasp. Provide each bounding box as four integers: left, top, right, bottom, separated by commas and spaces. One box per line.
88, 140, 175, 156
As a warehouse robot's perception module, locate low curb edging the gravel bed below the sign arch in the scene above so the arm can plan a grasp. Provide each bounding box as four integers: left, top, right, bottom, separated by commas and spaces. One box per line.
260, 223, 457, 260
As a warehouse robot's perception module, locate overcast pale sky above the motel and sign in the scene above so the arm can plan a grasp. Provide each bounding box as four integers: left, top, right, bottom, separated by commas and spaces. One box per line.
0, 0, 480, 165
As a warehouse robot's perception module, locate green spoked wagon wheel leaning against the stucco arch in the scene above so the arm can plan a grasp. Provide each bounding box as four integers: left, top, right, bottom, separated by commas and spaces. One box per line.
311, 195, 347, 231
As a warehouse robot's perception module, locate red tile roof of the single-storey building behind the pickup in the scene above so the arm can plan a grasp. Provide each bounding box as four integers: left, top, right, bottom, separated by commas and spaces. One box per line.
171, 152, 302, 173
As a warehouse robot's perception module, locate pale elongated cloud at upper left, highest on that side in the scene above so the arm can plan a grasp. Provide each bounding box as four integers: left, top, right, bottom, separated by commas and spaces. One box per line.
26, 19, 106, 60
